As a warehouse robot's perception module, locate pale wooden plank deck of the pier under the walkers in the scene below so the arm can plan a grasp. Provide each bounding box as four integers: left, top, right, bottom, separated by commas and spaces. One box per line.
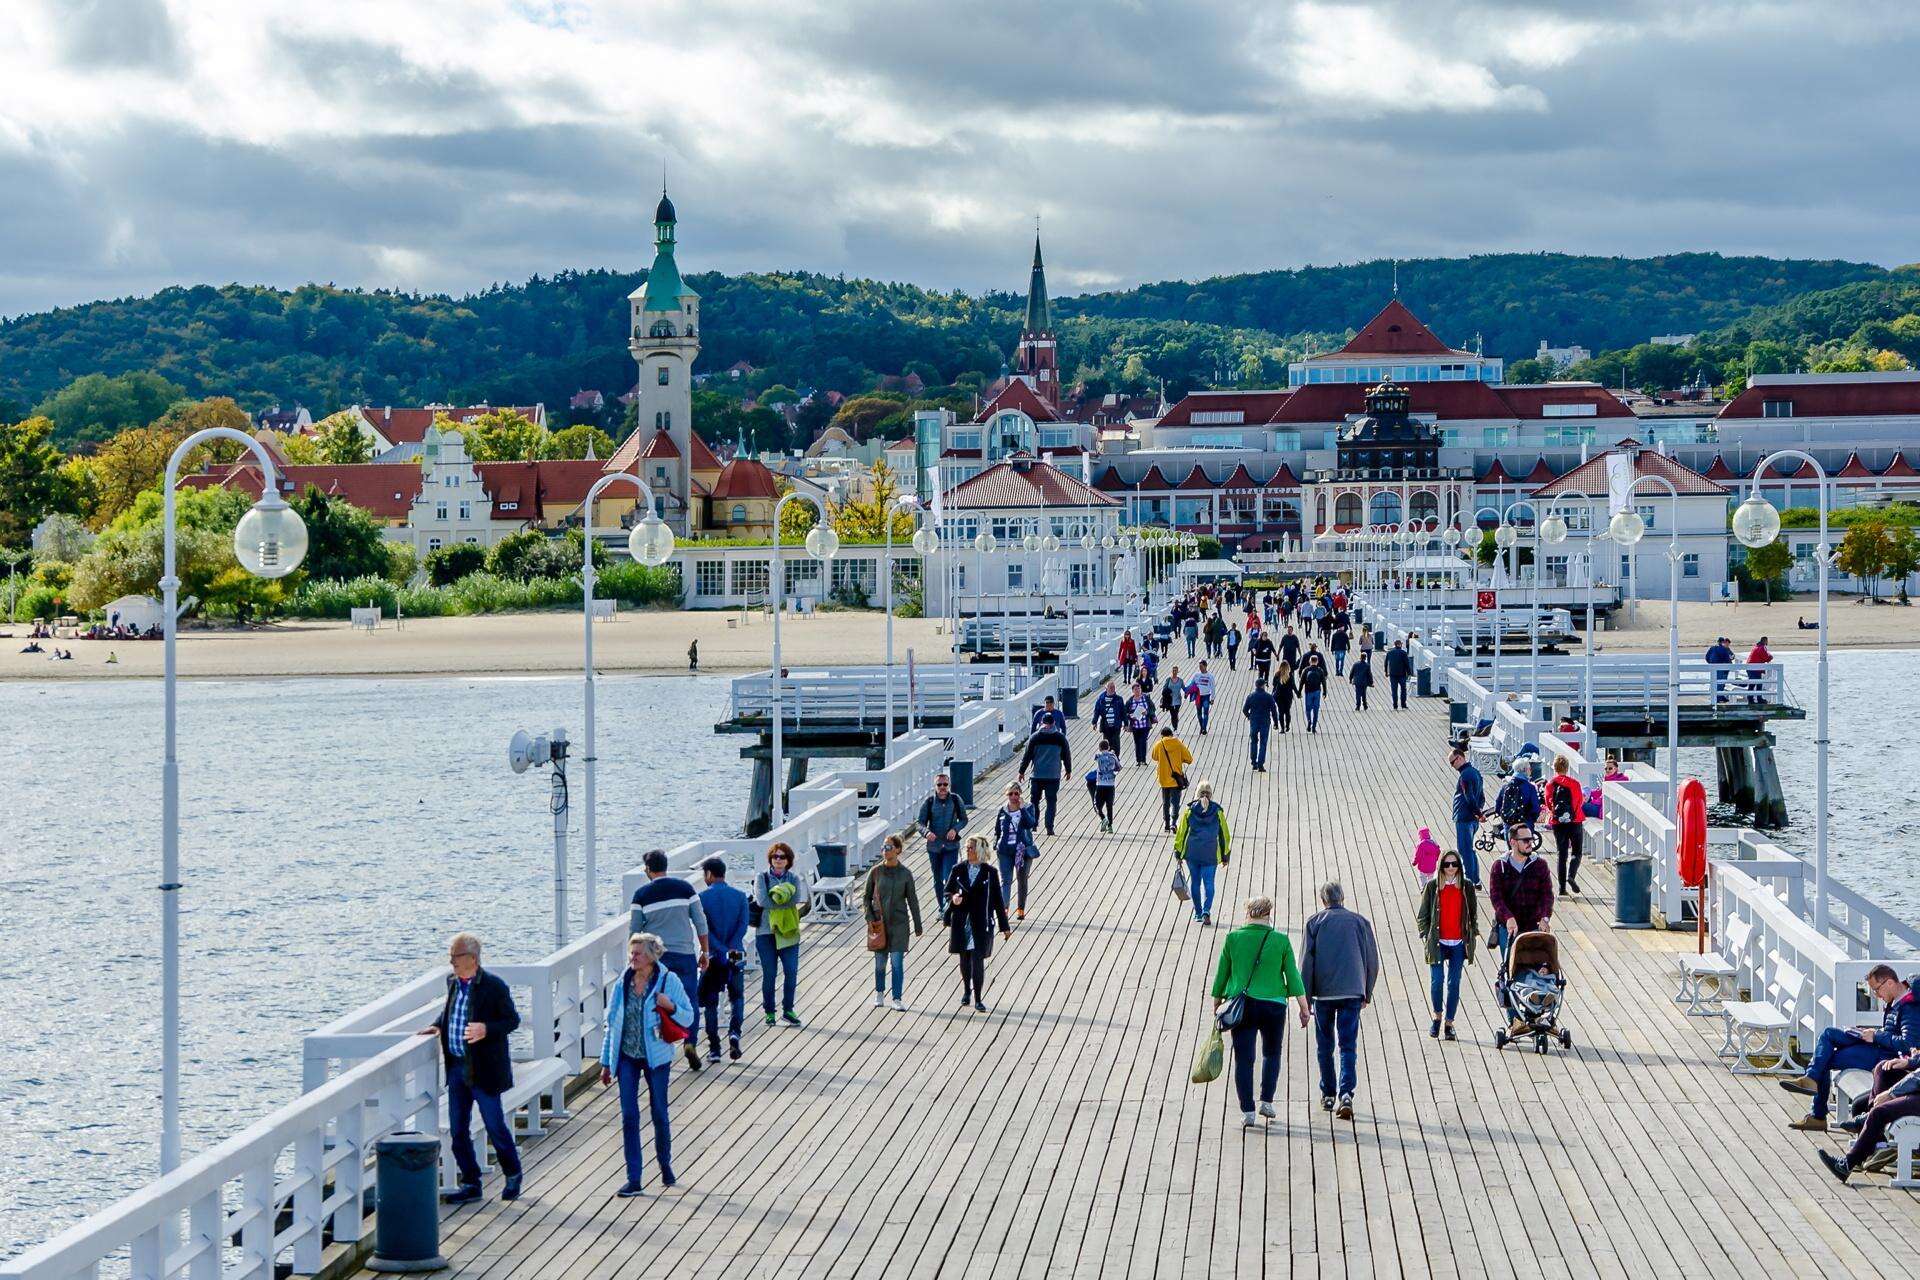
382, 660, 1920, 1280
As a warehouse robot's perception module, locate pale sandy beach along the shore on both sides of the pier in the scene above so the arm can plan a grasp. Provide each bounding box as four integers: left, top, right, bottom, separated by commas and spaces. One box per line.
0, 597, 1920, 679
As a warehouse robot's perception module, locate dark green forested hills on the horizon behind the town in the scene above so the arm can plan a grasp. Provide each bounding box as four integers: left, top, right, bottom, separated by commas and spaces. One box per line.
0, 253, 1887, 427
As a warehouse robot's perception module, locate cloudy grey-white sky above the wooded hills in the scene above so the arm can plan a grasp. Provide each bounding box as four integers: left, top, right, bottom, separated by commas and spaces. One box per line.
0, 0, 1920, 315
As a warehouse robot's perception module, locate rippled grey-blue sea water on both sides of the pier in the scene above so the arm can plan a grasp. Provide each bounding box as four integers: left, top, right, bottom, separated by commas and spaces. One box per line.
0, 652, 1920, 1257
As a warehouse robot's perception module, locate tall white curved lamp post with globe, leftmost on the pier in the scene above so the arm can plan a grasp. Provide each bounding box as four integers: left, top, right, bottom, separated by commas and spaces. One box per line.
159, 426, 307, 1173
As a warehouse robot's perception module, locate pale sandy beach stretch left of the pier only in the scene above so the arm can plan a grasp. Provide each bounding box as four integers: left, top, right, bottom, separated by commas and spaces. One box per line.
0, 610, 952, 679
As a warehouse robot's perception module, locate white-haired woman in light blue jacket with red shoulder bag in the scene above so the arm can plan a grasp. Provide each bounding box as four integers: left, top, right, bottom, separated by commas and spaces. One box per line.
601, 933, 693, 1196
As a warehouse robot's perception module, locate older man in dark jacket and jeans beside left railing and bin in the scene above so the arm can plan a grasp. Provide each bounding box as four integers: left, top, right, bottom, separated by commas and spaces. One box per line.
420, 933, 520, 1205
